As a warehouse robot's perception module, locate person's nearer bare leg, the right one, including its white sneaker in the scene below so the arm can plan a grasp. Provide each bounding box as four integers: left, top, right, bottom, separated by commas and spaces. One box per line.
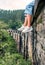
22, 14, 33, 33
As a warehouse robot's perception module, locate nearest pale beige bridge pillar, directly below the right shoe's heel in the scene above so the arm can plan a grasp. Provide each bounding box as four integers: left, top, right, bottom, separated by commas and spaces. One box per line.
28, 31, 33, 62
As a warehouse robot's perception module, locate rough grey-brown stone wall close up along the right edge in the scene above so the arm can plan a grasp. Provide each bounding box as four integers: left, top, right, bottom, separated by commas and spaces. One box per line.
33, 7, 45, 65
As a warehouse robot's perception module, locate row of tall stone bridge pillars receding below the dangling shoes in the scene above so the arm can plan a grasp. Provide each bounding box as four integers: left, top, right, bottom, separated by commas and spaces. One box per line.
8, 30, 33, 61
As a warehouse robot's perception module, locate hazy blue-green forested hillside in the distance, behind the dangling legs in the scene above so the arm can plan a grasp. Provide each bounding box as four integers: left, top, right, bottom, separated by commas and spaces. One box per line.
0, 10, 24, 29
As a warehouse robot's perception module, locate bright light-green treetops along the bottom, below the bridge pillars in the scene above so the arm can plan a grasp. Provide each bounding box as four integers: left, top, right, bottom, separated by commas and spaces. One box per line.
0, 53, 31, 65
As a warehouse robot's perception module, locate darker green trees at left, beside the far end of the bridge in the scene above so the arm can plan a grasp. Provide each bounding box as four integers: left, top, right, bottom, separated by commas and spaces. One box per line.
0, 30, 17, 54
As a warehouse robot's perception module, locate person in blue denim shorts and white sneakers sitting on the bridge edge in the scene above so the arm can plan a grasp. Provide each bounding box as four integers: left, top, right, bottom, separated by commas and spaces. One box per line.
18, 1, 35, 33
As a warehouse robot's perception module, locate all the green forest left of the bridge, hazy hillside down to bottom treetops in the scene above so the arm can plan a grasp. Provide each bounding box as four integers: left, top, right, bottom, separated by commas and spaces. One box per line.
0, 10, 32, 65
